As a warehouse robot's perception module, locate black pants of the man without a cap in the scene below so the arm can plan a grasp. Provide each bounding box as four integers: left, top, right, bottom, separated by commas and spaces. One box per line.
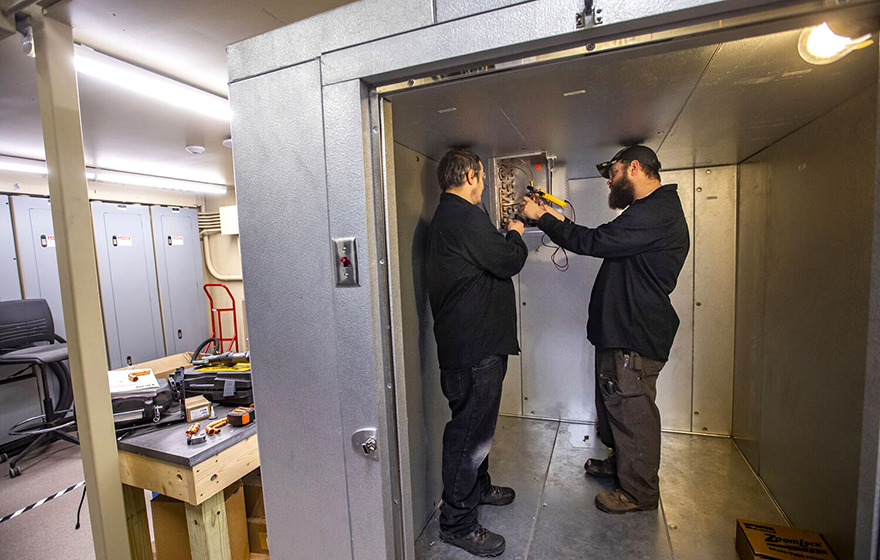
440, 356, 507, 539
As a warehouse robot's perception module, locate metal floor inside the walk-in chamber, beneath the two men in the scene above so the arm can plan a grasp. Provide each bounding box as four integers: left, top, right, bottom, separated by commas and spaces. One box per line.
416, 417, 785, 560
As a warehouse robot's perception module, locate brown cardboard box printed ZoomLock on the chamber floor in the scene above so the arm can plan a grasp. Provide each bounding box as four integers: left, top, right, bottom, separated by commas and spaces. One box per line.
736, 519, 837, 560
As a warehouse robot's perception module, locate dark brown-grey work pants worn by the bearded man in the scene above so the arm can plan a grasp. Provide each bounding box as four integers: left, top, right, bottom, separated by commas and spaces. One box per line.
596, 348, 666, 505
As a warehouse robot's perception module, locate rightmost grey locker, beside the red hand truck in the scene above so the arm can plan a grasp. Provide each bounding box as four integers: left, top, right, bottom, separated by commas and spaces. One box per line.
150, 206, 210, 354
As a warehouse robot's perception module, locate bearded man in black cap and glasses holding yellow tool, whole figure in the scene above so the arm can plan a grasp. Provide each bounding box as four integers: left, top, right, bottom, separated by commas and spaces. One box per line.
522, 146, 690, 513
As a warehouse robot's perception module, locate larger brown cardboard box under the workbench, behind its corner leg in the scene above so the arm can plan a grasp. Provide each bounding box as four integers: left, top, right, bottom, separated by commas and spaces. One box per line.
150, 480, 249, 560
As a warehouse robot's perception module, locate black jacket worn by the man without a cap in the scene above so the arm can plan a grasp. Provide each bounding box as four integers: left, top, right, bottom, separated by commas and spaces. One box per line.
427, 193, 528, 369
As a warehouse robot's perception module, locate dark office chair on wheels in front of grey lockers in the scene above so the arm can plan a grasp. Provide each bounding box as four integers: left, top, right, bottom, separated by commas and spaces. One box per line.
0, 299, 79, 478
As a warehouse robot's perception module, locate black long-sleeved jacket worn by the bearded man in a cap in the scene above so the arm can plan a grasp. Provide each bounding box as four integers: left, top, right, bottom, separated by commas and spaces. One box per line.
538, 184, 690, 362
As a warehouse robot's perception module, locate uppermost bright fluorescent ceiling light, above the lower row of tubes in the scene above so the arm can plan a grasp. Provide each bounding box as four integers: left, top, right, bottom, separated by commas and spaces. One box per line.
74, 45, 230, 122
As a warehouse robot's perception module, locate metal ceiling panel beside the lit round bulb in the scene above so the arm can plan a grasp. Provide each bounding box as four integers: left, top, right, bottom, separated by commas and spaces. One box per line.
658, 30, 877, 168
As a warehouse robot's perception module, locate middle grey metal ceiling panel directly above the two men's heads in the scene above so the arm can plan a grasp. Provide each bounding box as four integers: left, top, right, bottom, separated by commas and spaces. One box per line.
483, 46, 715, 178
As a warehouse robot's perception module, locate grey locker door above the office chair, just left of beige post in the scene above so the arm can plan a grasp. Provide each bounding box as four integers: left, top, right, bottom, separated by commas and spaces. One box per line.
10, 196, 66, 338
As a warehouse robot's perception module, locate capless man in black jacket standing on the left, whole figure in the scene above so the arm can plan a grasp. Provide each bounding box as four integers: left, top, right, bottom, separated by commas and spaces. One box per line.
427, 150, 528, 556
